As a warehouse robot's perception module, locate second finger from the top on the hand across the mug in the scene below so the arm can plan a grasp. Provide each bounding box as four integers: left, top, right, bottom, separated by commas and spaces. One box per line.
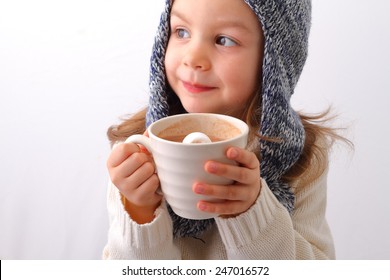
204, 161, 258, 184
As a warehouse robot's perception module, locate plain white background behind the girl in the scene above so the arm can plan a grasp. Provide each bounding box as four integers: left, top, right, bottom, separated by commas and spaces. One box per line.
0, 0, 390, 259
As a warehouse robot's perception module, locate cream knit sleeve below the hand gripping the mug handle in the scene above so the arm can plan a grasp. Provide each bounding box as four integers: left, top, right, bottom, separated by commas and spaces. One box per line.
103, 182, 180, 260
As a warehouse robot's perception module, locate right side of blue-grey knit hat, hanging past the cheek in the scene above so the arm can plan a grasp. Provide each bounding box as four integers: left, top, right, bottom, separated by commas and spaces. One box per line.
244, 0, 311, 211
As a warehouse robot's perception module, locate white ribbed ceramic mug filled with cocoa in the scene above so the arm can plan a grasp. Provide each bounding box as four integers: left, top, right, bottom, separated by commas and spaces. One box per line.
126, 113, 249, 220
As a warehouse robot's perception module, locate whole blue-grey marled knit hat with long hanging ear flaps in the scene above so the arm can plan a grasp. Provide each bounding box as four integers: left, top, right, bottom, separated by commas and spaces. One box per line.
146, 0, 311, 237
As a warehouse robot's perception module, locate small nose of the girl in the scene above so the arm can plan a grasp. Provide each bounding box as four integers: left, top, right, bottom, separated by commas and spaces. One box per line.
183, 41, 211, 71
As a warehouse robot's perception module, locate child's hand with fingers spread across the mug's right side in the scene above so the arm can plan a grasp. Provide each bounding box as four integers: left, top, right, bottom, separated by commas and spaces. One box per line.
193, 147, 261, 216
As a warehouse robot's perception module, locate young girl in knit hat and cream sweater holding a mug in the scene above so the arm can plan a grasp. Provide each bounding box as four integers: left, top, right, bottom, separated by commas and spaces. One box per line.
103, 0, 337, 259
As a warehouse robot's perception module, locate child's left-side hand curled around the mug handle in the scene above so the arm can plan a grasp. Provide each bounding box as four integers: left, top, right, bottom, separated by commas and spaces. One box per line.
107, 140, 162, 224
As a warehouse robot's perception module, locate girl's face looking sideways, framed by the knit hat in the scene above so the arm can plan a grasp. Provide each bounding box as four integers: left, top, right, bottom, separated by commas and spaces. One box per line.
165, 0, 263, 117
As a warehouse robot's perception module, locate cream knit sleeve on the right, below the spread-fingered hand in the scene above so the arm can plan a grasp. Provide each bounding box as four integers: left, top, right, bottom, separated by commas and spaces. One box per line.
216, 167, 335, 259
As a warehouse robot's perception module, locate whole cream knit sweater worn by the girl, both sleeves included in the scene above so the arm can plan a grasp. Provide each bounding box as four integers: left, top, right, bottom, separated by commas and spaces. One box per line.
103, 163, 335, 260
